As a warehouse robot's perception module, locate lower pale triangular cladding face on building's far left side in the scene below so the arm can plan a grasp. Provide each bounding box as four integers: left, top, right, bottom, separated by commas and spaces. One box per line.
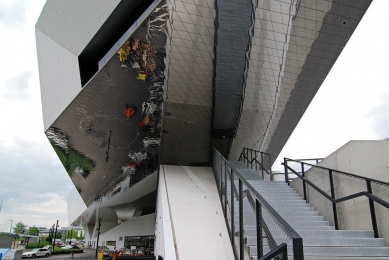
35, 30, 81, 130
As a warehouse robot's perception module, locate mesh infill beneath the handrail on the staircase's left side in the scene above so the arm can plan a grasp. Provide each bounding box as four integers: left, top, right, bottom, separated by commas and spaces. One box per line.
213, 149, 302, 259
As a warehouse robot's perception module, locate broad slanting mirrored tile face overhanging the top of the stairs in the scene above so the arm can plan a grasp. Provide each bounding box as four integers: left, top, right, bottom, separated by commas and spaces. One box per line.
229, 0, 371, 161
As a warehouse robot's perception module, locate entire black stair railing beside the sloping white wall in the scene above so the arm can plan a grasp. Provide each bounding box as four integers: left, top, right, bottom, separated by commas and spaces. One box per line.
212, 149, 304, 260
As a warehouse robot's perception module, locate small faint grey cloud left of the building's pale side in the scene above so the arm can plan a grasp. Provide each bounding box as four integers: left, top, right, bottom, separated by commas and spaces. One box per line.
4, 71, 34, 100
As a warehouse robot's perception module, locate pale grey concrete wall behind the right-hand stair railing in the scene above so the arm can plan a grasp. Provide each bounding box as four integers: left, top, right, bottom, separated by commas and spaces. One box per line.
291, 140, 389, 245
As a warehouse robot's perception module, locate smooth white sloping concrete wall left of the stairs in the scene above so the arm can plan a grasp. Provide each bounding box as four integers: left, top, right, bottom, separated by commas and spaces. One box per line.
160, 165, 234, 260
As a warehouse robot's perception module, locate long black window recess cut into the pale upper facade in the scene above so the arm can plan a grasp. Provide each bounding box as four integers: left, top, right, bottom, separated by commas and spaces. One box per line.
78, 0, 154, 86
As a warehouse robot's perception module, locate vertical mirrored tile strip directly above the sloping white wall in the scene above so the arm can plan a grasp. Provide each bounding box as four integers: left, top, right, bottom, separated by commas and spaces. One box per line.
161, 0, 215, 165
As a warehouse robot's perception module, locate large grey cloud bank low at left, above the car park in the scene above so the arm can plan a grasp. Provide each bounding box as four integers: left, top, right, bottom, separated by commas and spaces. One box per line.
0, 138, 74, 229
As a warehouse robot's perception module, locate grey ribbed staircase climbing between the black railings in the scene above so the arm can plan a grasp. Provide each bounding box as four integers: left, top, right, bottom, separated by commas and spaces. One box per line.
227, 162, 389, 260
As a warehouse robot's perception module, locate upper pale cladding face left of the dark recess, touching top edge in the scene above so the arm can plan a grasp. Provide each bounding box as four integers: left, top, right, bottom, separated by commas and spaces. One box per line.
36, 0, 120, 56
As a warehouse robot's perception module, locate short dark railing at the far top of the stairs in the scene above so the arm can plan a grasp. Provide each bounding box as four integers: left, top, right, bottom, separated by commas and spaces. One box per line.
238, 148, 274, 181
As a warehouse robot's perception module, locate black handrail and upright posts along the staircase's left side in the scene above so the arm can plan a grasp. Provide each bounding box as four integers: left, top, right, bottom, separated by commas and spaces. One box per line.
214, 148, 304, 259
